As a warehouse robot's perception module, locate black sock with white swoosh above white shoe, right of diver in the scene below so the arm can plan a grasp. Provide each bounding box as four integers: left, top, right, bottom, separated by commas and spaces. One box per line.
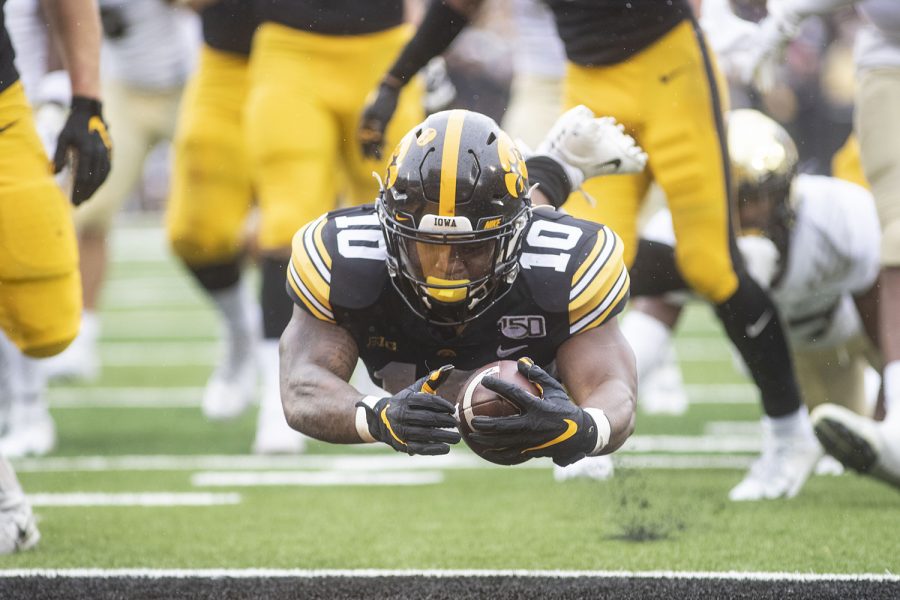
716, 273, 800, 417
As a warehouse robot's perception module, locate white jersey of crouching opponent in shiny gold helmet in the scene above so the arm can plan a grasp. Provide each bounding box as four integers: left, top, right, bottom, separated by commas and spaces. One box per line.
641, 175, 881, 348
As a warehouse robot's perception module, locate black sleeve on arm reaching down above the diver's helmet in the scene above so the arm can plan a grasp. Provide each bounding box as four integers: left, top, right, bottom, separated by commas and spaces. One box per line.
388, 0, 469, 86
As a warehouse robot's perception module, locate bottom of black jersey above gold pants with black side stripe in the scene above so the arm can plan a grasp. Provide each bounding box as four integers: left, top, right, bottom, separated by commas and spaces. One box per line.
544, 0, 692, 67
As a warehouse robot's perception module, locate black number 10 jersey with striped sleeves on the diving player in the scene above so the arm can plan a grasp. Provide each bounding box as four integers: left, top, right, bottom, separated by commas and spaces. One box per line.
287, 204, 629, 384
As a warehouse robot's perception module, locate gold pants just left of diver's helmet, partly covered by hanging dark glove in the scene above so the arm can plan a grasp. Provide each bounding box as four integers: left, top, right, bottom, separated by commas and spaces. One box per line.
246, 23, 423, 251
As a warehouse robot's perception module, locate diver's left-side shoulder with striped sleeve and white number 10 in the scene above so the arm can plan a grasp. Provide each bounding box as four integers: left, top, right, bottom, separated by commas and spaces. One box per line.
287, 205, 389, 323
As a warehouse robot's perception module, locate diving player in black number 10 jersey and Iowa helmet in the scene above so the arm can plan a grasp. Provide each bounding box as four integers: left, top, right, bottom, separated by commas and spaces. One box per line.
280, 107, 646, 465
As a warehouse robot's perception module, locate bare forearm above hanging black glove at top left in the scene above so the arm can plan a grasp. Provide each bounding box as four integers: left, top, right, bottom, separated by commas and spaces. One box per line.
42, 0, 102, 100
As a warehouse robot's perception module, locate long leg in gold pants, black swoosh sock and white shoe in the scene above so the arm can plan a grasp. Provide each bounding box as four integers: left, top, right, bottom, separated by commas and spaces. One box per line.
566, 22, 821, 500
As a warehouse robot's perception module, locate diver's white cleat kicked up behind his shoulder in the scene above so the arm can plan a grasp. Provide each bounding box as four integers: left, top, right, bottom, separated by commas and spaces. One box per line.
535, 105, 647, 190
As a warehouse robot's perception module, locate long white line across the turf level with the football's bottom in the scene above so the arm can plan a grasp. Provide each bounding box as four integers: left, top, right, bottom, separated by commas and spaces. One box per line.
12, 451, 754, 473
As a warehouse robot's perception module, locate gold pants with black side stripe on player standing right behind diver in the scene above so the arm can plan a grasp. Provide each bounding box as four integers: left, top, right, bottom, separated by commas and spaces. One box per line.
565, 20, 738, 304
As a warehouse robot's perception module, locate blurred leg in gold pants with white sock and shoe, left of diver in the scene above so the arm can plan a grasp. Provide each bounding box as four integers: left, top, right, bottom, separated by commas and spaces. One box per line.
166, 47, 259, 419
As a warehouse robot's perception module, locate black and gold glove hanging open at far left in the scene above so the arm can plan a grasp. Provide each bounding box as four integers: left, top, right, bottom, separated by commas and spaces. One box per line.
53, 96, 112, 206
